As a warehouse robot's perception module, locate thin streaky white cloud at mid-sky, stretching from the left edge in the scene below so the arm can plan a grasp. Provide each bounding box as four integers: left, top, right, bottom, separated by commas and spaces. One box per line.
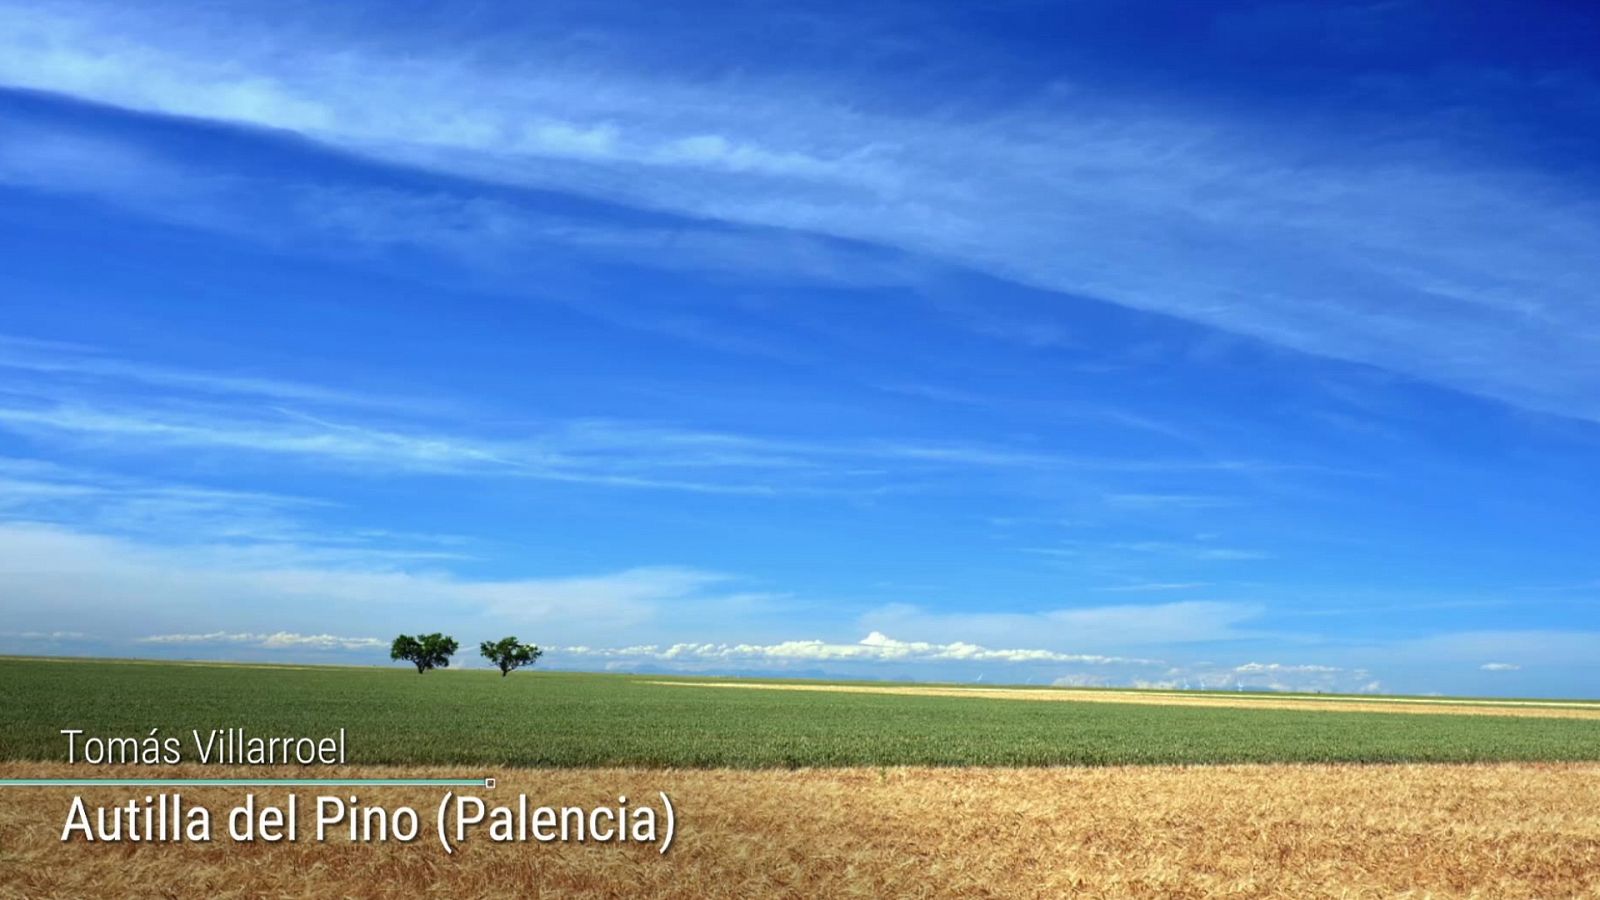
0, 340, 1299, 493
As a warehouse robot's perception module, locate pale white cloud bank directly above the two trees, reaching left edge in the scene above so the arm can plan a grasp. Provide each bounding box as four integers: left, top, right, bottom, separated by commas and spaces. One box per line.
0, 522, 742, 641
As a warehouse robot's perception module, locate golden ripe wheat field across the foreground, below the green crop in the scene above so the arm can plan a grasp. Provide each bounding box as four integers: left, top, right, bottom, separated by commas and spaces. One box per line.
0, 762, 1600, 898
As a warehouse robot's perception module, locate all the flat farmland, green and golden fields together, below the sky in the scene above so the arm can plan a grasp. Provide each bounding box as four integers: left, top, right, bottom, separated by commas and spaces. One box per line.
0, 658, 1600, 900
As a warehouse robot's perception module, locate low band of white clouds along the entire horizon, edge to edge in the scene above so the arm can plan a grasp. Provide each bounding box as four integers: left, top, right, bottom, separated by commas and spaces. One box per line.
0, 522, 1595, 693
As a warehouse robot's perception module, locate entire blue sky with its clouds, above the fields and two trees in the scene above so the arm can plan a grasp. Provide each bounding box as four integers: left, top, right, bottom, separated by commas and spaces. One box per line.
0, 0, 1600, 697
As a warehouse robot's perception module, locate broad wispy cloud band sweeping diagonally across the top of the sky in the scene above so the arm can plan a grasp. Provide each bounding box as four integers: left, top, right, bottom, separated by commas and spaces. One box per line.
0, 3, 1600, 418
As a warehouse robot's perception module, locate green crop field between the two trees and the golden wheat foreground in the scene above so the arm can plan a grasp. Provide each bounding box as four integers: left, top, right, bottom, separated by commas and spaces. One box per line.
0, 658, 1600, 767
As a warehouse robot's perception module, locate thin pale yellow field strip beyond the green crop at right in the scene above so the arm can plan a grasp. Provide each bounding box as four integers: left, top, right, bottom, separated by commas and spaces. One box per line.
645, 681, 1600, 719
